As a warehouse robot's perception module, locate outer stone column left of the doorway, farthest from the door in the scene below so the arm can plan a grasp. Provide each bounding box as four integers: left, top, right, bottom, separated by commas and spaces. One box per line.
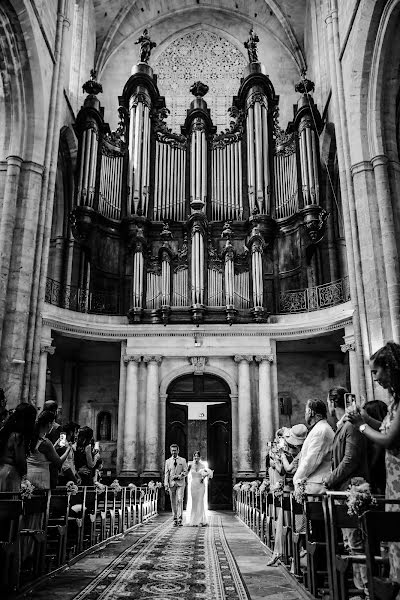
121, 354, 141, 477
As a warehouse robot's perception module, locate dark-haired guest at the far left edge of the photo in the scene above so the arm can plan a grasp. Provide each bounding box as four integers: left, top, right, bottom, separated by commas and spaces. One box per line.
0, 402, 36, 492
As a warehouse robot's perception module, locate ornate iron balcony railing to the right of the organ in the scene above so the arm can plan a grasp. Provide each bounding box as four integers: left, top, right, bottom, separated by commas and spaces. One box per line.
279, 277, 350, 313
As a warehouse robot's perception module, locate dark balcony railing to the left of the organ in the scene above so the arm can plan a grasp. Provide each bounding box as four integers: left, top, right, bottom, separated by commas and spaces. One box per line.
45, 278, 122, 315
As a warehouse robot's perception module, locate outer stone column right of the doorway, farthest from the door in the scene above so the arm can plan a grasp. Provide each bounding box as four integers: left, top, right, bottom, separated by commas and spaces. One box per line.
255, 354, 275, 477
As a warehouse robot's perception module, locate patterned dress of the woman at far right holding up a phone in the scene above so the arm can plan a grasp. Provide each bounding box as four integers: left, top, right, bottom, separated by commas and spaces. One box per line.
380, 400, 400, 583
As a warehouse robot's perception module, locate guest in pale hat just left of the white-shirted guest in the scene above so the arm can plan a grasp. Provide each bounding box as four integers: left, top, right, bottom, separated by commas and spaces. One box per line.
267, 424, 307, 567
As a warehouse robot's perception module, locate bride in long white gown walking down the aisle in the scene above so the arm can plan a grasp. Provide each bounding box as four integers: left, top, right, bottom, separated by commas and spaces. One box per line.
186, 452, 213, 526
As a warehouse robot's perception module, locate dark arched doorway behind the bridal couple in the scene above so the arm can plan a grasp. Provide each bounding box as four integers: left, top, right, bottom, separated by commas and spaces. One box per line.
165, 373, 232, 508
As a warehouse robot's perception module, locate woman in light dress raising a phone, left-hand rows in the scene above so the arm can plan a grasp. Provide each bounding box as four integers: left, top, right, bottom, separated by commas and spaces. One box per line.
27, 410, 71, 490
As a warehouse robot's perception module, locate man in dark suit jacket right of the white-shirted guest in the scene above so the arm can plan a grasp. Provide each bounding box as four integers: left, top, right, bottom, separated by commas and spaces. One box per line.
325, 387, 369, 598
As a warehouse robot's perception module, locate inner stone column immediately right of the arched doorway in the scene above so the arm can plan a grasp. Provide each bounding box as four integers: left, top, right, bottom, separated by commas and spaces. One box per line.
234, 355, 255, 477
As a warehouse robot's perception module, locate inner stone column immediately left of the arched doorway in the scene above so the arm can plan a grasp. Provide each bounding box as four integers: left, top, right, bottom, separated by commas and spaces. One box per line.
142, 356, 162, 477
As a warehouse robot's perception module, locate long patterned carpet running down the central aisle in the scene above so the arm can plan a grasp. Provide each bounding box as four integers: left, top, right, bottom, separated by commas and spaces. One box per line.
75, 515, 248, 600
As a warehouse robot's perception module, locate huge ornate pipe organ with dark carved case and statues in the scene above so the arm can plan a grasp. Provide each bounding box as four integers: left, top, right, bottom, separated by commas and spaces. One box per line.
71, 51, 326, 324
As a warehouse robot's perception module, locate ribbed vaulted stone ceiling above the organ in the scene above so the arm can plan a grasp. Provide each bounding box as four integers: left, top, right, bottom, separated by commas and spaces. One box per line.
93, 0, 307, 71
